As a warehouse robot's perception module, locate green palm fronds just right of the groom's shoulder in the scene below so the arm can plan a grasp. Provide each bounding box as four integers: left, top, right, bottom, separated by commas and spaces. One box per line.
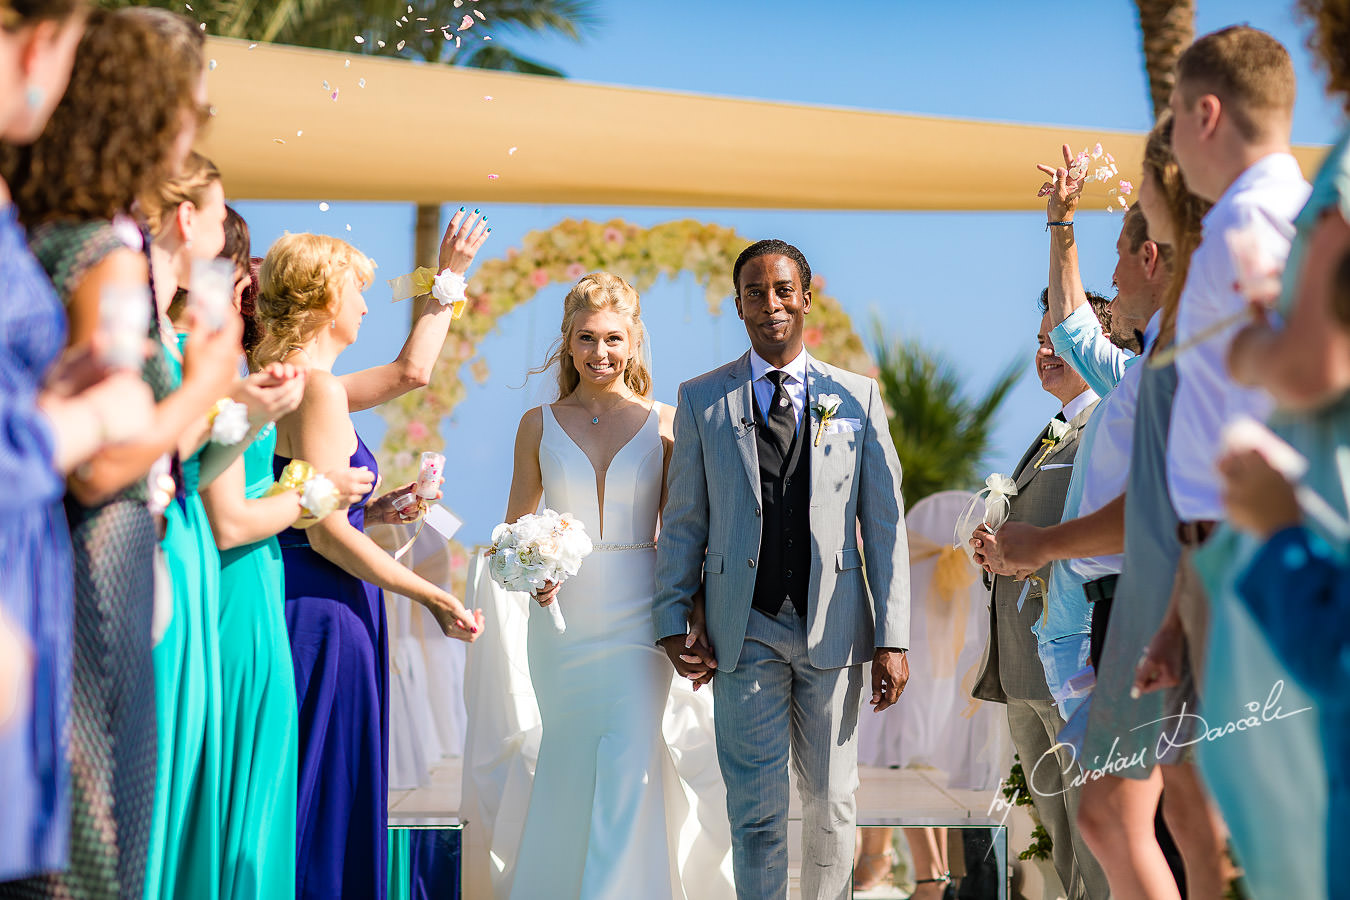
872, 321, 1025, 509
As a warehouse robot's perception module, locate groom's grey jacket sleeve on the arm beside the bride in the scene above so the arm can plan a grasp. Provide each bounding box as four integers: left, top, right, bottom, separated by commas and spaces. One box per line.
652, 386, 709, 644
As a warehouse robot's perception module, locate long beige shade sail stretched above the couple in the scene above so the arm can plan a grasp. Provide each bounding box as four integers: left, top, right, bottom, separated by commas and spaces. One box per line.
201, 38, 1324, 210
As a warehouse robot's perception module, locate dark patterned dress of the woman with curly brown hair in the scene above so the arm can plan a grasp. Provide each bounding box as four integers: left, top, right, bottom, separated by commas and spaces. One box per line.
0, 221, 174, 897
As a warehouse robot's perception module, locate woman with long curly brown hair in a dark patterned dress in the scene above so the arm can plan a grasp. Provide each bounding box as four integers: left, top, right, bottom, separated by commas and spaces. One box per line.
0, 8, 239, 897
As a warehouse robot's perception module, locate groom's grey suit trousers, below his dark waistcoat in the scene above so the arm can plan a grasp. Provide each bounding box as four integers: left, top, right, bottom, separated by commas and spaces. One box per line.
713, 603, 864, 900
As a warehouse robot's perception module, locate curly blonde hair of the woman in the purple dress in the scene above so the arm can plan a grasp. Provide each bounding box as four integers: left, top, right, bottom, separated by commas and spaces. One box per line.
251, 235, 375, 368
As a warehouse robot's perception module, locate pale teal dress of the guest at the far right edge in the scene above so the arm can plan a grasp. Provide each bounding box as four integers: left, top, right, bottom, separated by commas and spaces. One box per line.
1196, 131, 1350, 897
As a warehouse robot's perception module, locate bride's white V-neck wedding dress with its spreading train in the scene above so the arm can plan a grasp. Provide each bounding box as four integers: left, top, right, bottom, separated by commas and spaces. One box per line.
464, 406, 734, 900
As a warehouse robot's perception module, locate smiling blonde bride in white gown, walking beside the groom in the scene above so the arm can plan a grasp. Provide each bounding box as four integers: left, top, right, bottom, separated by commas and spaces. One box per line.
491, 273, 732, 900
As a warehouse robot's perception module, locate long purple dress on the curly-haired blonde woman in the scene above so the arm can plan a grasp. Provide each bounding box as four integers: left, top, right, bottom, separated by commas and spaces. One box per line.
273, 434, 389, 900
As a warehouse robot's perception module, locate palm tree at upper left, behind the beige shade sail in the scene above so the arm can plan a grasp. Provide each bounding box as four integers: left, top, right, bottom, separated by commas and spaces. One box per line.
96, 0, 599, 264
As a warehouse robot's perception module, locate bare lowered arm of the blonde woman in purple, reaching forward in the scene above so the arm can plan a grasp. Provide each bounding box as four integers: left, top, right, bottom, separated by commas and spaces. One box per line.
287, 370, 482, 641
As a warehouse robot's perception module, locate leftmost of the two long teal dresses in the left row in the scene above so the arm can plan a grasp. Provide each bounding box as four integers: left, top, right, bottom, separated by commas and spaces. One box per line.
146, 339, 223, 900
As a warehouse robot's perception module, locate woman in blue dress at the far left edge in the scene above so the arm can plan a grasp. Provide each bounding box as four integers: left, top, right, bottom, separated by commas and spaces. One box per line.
0, 0, 159, 892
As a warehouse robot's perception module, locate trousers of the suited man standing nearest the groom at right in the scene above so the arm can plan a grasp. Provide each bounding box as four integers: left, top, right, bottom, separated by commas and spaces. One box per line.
1008, 698, 1111, 900
